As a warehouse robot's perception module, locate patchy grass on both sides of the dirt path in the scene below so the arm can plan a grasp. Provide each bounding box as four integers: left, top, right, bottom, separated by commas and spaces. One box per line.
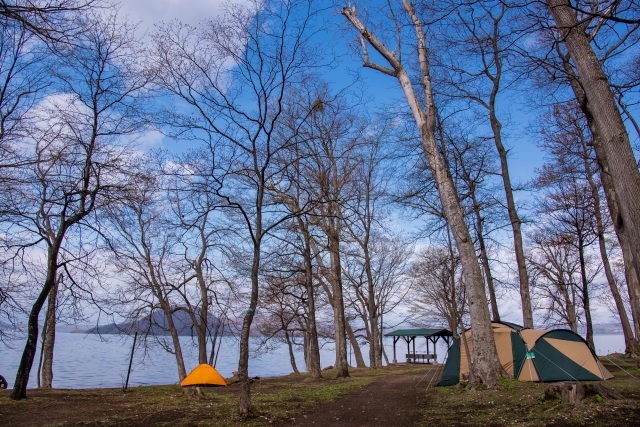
0, 355, 640, 427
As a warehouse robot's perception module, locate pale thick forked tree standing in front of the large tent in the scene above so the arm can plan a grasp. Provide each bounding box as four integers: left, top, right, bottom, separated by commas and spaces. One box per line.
341, 0, 500, 387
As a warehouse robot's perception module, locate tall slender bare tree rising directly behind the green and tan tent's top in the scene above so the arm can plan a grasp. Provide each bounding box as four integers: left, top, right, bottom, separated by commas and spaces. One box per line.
437, 1, 533, 328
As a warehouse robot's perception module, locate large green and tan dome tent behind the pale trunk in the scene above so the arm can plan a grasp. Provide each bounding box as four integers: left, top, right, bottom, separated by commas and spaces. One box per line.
438, 322, 613, 386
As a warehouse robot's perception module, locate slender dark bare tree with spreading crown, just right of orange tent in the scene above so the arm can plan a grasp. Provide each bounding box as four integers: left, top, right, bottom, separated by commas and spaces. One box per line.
154, 1, 320, 415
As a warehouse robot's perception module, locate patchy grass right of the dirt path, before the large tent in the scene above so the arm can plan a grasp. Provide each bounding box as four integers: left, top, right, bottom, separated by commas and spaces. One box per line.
421, 355, 640, 427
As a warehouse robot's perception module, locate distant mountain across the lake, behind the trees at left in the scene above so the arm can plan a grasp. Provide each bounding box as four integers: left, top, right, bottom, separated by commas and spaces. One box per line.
83, 310, 232, 336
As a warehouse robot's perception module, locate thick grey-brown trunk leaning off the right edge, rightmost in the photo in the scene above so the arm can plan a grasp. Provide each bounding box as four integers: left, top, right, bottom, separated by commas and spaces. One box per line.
547, 0, 640, 288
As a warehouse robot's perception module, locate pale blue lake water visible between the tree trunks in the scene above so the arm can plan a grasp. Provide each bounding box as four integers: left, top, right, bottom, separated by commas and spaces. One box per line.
0, 332, 624, 388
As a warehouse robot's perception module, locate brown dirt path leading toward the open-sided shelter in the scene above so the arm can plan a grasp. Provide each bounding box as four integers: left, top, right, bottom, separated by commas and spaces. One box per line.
278, 371, 434, 427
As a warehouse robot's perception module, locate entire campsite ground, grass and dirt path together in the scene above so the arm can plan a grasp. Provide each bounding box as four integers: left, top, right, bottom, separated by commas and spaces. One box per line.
0, 357, 640, 427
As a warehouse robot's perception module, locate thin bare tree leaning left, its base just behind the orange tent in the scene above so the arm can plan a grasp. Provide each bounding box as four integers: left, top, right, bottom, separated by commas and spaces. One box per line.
101, 161, 193, 380
